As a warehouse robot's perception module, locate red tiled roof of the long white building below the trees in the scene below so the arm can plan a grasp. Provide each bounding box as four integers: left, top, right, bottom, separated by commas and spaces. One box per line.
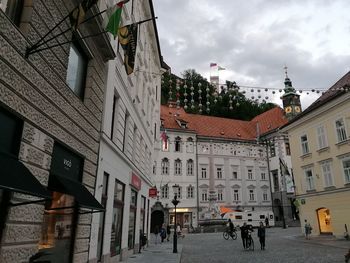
161, 105, 287, 140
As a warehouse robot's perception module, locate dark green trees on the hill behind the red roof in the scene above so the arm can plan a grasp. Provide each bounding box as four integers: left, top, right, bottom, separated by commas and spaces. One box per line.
161, 69, 276, 121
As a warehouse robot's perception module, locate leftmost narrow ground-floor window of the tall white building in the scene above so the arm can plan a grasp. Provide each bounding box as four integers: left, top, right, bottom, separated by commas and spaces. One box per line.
97, 172, 109, 260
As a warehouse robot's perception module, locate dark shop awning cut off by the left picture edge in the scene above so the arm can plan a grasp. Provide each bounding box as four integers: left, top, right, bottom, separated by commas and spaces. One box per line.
0, 153, 51, 199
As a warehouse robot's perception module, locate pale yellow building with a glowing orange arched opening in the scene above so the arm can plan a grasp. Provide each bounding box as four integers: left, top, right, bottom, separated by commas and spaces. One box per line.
282, 72, 350, 238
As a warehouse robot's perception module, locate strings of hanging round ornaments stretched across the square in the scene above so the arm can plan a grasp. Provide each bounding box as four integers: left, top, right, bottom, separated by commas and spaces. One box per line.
162, 73, 350, 114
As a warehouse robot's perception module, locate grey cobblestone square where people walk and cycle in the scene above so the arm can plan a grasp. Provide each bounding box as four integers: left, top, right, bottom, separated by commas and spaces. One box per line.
181, 228, 350, 263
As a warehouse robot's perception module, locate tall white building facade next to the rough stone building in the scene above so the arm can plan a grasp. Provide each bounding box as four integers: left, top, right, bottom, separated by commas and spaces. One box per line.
89, 1, 162, 262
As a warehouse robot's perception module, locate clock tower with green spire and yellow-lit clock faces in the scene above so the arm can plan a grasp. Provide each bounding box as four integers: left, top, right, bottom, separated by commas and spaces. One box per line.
281, 67, 301, 120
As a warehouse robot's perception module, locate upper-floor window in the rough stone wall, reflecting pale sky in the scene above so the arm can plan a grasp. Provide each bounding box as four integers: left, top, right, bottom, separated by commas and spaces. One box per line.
66, 42, 88, 98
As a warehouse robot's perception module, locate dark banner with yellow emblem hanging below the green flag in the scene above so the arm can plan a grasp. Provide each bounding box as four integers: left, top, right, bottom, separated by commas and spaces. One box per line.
118, 23, 139, 75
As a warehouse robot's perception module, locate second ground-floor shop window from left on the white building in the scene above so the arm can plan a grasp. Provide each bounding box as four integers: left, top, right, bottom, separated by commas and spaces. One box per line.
110, 181, 125, 256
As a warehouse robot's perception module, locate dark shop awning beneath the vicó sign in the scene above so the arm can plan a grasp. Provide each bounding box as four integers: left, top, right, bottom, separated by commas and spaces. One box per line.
49, 175, 105, 211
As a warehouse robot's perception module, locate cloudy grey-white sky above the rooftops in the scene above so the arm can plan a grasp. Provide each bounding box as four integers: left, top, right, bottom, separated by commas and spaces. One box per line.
153, 0, 350, 108
